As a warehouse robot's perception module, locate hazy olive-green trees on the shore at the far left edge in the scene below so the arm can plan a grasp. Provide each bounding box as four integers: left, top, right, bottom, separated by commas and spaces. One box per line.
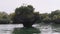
0, 12, 10, 24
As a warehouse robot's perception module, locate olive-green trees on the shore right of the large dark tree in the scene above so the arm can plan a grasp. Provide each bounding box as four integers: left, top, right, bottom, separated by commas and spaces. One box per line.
40, 10, 60, 24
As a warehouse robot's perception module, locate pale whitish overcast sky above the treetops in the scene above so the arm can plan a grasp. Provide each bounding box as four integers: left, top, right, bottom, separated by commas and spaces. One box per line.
0, 0, 60, 13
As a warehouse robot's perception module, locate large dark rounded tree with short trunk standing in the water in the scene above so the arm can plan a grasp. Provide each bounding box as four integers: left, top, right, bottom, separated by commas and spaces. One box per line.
12, 5, 40, 28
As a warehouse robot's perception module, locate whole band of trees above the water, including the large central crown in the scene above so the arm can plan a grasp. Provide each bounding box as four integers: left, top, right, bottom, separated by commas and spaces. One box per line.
0, 5, 60, 24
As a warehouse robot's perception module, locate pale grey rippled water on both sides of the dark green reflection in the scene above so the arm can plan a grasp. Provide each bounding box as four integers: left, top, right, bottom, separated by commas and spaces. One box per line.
0, 24, 60, 34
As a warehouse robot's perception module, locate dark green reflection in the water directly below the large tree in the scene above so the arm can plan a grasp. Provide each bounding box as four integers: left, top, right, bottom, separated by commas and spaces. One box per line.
13, 28, 40, 34
